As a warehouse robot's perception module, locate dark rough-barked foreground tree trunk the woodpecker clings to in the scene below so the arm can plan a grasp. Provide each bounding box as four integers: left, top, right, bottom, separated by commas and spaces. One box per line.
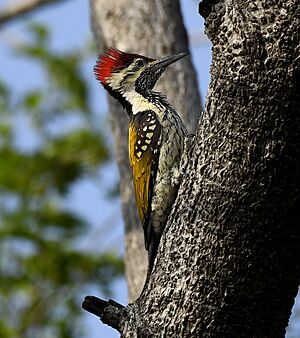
84, 0, 300, 338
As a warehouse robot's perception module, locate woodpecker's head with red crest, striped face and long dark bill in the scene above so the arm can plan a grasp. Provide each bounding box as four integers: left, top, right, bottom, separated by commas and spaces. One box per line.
94, 48, 188, 95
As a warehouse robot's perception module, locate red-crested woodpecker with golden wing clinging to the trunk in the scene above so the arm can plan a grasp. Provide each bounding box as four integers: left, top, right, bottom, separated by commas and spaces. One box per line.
94, 48, 188, 276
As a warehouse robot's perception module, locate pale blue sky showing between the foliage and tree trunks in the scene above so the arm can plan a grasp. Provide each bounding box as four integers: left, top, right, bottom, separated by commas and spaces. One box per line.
0, 0, 300, 338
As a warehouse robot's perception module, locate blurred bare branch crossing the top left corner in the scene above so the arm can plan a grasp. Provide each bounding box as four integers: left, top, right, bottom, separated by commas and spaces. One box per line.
0, 0, 68, 26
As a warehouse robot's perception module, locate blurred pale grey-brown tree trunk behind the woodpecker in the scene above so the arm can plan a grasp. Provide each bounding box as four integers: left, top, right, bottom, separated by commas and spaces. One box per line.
91, 0, 201, 301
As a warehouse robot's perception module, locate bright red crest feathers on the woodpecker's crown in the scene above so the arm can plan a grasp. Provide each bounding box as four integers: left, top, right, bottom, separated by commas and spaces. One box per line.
94, 48, 145, 85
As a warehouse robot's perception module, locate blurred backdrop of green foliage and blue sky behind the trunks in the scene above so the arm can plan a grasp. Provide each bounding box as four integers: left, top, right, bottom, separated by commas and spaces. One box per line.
0, 0, 300, 338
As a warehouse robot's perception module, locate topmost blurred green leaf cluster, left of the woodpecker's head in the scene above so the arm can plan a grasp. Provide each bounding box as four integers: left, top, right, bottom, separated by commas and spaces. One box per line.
17, 24, 90, 114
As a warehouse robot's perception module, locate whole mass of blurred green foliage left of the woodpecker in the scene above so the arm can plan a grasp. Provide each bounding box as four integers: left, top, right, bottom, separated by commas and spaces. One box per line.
0, 24, 123, 338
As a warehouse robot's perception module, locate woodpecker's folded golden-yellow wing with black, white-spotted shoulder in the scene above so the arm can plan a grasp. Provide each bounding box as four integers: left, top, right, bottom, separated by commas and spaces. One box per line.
129, 110, 161, 249
